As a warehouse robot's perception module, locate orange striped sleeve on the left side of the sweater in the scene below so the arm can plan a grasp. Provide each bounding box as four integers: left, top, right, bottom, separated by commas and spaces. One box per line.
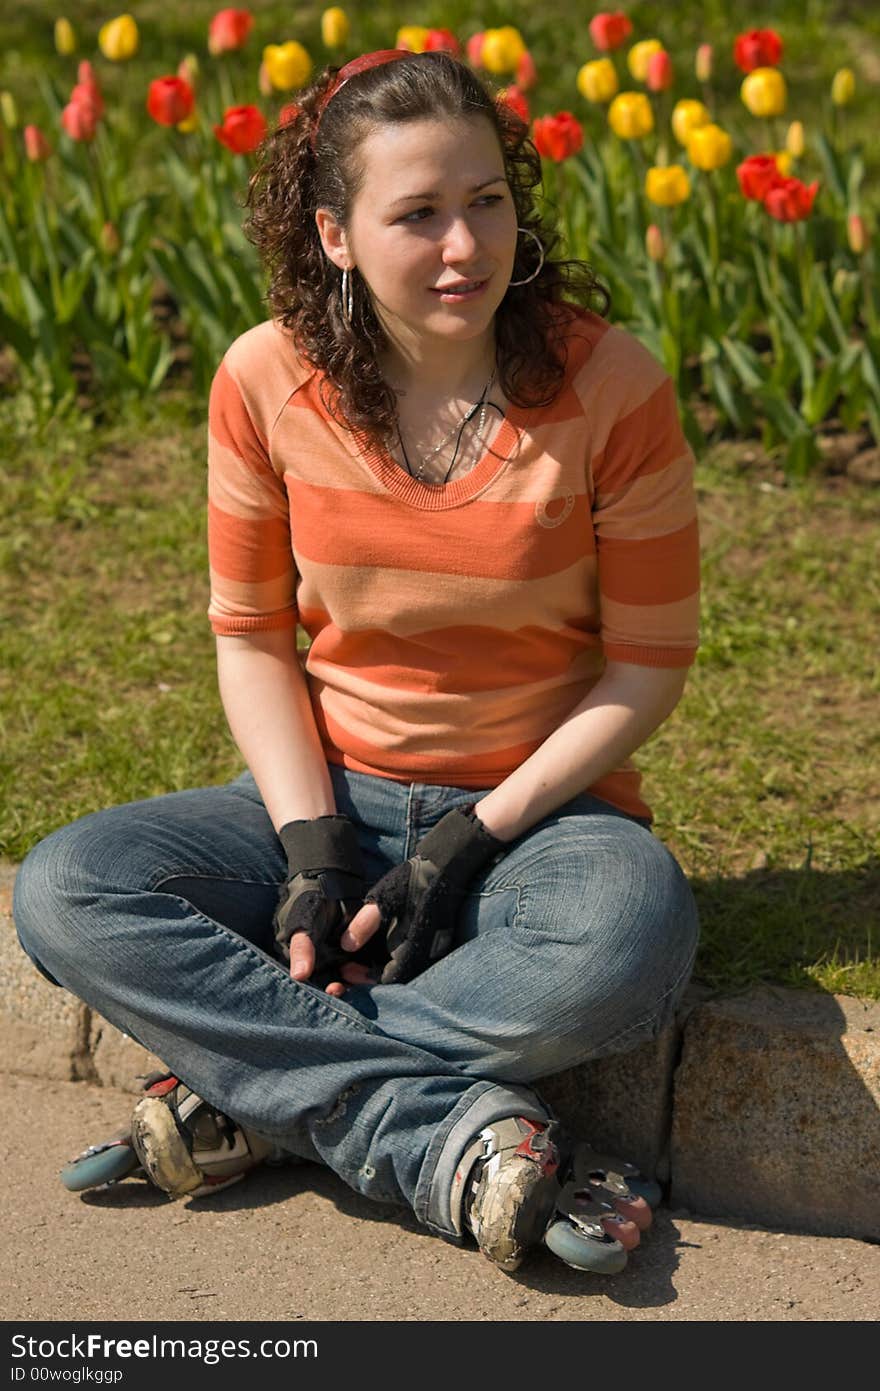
209, 360, 298, 636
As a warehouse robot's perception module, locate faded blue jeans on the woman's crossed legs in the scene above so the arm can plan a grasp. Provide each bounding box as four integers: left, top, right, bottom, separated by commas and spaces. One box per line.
14, 766, 696, 1237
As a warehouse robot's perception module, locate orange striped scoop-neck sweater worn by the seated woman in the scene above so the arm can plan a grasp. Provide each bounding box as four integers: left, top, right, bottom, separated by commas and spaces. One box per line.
209, 312, 698, 817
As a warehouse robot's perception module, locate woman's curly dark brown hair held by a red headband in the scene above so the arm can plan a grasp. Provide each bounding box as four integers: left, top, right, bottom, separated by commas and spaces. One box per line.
246, 51, 610, 442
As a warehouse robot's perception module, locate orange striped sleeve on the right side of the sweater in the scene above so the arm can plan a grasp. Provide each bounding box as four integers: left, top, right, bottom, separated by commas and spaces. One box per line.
592, 361, 699, 666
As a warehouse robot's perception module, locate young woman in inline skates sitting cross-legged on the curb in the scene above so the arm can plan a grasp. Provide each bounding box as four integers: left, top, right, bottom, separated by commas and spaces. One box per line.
15, 51, 698, 1270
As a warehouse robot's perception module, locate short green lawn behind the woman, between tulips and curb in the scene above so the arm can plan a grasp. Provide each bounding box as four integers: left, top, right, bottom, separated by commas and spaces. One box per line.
0, 395, 880, 997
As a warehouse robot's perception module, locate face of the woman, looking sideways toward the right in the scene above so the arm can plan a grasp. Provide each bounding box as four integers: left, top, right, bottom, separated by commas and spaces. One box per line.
318, 117, 517, 361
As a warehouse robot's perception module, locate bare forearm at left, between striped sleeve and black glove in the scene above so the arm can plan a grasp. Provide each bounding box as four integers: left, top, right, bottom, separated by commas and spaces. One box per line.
217, 627, 336, 830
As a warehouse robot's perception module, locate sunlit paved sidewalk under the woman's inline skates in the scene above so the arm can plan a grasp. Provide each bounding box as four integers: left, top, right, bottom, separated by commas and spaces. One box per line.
0, 1075, 880, 1324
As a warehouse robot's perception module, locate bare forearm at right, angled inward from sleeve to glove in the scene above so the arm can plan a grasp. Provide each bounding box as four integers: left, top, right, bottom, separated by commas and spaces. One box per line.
474, 661, 687, 840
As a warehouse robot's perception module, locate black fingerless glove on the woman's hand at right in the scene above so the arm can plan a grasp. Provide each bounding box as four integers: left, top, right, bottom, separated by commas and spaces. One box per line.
364, 807, 507, 985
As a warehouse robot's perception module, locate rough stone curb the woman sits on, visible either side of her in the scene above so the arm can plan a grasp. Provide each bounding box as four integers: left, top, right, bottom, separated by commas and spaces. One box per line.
0, 865, 880, 1241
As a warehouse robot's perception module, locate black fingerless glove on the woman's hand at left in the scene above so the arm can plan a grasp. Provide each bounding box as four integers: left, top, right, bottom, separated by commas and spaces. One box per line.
272, 815, 367, 985
